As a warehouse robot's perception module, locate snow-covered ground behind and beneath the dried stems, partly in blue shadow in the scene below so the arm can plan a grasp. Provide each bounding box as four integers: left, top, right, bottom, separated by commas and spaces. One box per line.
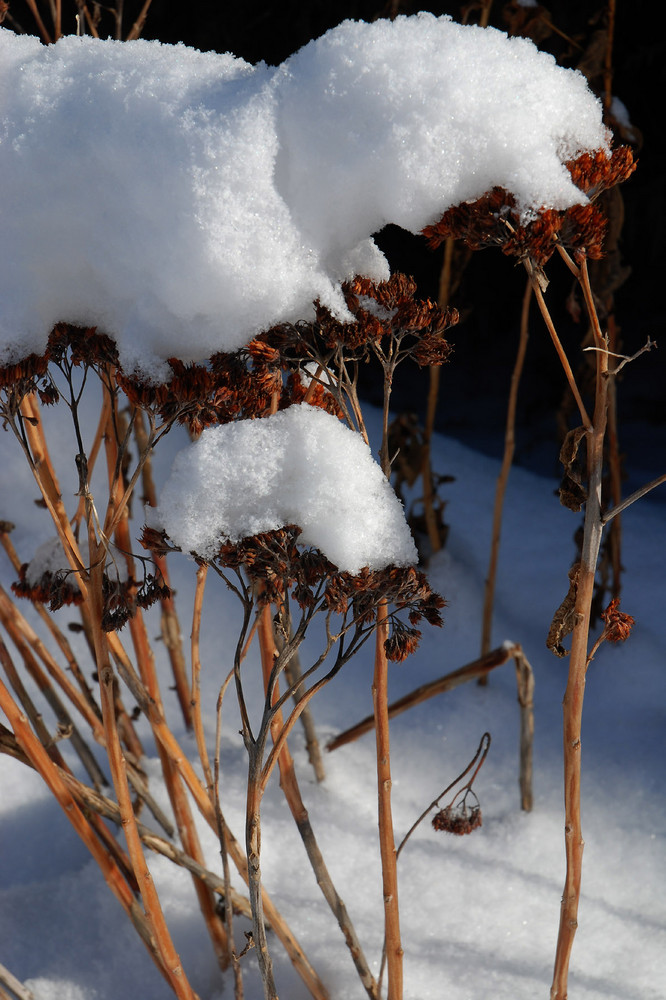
0, 400, 666, 1000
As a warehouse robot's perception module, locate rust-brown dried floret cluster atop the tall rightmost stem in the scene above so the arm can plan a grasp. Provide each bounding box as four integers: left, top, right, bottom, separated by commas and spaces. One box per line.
423, 146, 636, 266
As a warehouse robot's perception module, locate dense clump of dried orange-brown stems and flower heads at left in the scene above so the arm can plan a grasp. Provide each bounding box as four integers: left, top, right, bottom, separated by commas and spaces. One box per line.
0, 275, 455, 1000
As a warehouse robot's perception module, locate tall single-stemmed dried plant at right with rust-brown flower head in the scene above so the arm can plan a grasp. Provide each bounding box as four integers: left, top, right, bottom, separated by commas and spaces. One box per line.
425, 147, 663, 1000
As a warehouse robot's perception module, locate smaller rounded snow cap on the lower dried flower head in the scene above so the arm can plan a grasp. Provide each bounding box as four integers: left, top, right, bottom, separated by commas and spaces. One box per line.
153, 403, 418, 573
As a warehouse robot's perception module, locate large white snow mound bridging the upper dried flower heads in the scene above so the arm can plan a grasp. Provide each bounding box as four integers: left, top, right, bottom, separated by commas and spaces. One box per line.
0, 14, 607, 379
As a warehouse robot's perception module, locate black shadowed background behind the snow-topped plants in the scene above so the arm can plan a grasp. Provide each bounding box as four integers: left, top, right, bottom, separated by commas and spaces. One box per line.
5, 0, 666, 492
